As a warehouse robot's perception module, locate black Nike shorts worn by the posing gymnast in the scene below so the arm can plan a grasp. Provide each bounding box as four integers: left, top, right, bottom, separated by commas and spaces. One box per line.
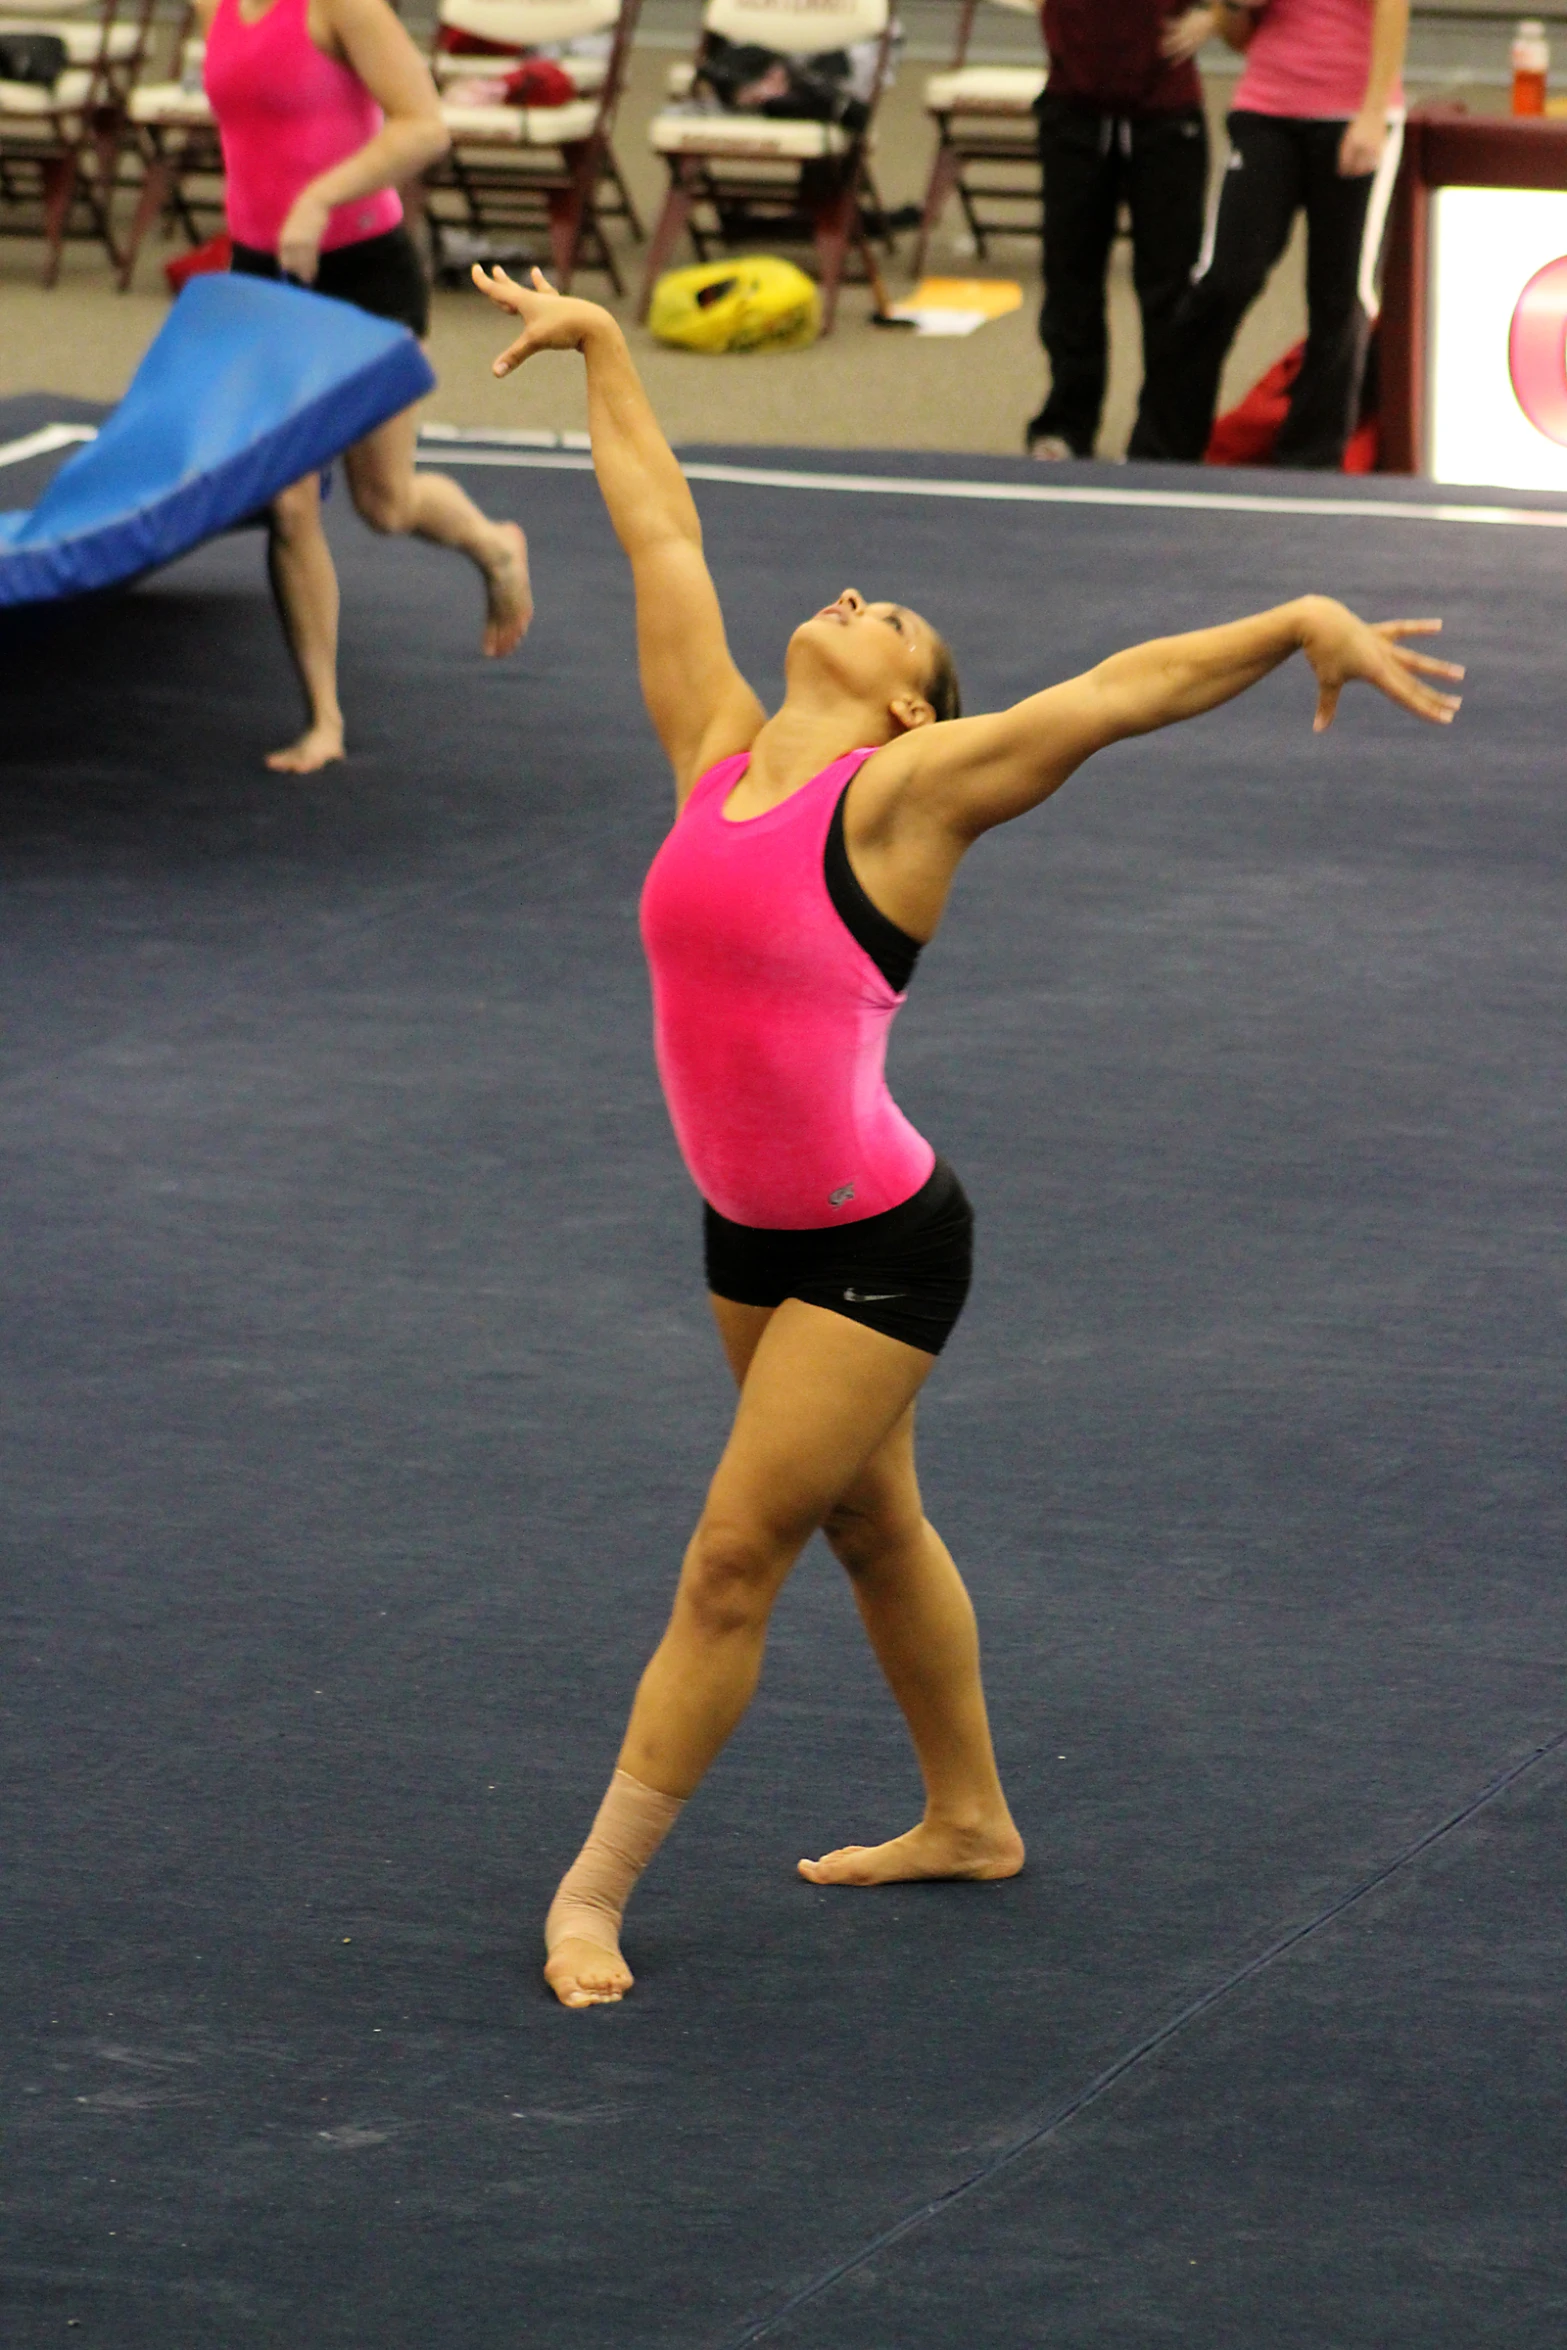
705, 1159, 975, 1354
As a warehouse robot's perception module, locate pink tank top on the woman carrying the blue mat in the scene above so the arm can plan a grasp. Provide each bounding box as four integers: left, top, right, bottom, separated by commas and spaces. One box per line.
204, 0, 402, 254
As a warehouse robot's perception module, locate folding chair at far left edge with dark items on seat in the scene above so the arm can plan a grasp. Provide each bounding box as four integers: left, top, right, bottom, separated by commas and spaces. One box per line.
0, 0, 153, 287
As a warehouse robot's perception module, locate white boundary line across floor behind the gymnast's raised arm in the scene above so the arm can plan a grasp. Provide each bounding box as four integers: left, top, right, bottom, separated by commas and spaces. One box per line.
418, 439, 1567, 531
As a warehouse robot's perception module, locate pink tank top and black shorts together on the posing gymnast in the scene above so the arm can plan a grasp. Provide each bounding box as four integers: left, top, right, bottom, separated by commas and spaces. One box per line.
641, 750, 973, 1354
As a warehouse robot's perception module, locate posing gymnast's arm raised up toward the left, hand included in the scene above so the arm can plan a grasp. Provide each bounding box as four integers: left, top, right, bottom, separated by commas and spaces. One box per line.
475, 268, 766, 801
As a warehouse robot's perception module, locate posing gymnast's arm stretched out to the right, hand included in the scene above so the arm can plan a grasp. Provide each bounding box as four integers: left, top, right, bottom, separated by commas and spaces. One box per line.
904, 595, 1464, 841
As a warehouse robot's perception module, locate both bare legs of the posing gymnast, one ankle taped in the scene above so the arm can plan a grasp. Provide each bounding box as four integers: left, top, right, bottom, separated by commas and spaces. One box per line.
545, 1297, 1024, 2007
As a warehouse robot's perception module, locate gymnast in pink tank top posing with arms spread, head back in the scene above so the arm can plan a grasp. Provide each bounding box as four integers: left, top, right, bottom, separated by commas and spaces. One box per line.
475, 270, 1461, 2007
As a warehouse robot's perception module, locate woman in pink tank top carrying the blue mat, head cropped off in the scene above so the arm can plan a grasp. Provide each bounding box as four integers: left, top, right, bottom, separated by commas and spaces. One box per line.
202, 0, 533, 776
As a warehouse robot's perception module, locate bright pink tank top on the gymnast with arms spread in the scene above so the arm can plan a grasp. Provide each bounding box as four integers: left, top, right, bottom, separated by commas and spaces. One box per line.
641, 750, 935, 1231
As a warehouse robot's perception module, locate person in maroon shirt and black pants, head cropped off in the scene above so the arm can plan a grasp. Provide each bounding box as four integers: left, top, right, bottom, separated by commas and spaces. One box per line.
1024, 0, 1215, 458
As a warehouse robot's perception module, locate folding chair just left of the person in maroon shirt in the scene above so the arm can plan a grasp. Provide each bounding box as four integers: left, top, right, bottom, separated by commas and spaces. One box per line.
914, 0, 1045, 277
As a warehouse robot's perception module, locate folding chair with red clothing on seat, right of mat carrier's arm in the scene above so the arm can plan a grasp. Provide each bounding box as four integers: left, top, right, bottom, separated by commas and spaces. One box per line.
421, 0, 641, 291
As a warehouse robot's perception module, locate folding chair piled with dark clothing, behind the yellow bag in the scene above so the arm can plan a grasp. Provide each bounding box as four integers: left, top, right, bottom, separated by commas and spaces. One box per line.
641, 0, 893, 334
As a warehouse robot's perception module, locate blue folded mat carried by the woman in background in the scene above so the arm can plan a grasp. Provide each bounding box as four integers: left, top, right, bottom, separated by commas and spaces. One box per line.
0, 275, 435, 604
